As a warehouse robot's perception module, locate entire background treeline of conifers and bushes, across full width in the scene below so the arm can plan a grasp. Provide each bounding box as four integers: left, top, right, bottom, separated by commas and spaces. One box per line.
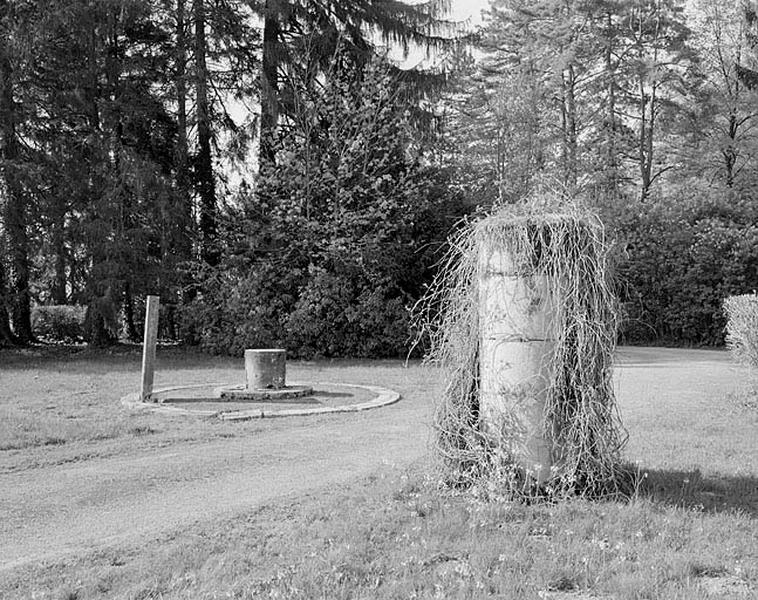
0, 0, 758, 356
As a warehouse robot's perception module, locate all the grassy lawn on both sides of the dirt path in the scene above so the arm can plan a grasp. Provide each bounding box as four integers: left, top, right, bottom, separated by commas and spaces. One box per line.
0, 349, 758, 600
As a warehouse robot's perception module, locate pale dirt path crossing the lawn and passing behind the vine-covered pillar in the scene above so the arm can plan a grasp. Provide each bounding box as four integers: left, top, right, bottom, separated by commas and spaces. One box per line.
0, 349, 748, 570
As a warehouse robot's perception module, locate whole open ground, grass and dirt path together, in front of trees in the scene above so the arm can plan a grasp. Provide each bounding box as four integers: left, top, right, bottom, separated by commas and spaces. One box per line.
0, 348, 758, 599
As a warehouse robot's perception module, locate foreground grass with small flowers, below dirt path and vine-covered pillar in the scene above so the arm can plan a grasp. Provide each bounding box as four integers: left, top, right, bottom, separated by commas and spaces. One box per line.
0, 469, 758, 600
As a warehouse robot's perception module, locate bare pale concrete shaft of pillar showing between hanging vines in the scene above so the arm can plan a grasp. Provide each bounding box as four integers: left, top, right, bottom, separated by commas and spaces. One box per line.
478, 246, 555, 484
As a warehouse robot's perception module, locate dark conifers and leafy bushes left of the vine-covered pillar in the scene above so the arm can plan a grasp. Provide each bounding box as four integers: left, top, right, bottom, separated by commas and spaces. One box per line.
0, 0, 464, 354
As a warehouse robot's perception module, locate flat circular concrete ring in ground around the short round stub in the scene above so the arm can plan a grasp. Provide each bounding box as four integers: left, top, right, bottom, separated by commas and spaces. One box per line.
121, 382, 400, 421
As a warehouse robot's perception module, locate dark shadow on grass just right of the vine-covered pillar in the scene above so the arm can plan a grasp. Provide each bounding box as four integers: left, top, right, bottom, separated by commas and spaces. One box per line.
638, 469, 758, 518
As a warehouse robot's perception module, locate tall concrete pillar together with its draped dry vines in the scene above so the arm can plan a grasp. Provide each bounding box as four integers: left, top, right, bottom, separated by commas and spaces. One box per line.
419, 203, 626, 494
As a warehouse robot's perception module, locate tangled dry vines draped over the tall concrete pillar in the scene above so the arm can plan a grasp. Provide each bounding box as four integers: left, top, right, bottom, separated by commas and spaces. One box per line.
418, 204, 626, 496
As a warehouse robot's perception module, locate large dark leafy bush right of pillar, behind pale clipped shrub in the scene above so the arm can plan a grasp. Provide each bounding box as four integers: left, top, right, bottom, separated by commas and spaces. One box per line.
617, 191, 758, 345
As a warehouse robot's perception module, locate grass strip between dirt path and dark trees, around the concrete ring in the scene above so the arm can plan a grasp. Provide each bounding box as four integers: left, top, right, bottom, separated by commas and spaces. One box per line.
0, 346, 429, 472
